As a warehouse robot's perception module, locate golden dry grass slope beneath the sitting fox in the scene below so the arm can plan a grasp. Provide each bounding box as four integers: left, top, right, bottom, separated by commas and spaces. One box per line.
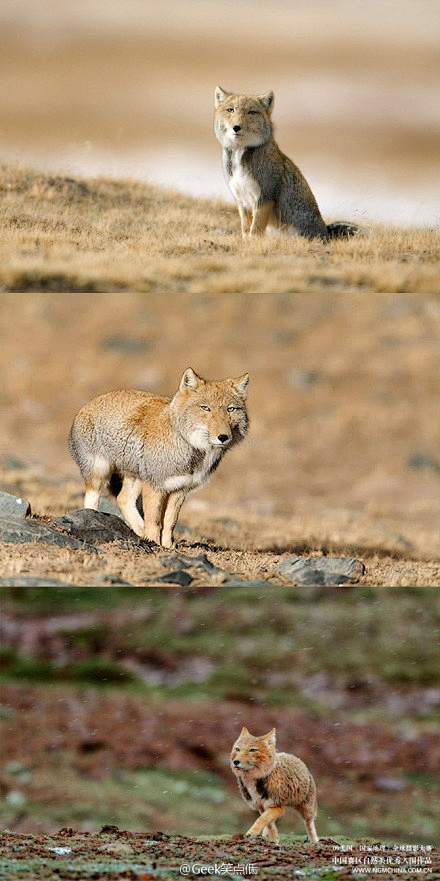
0, 165, 440, 293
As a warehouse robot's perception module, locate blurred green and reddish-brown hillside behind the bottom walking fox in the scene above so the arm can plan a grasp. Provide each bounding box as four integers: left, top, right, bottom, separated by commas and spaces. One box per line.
0, 587, 440, 844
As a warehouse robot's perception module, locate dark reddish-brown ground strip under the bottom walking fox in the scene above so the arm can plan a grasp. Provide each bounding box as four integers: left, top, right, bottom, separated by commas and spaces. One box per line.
0, 826, 440, 881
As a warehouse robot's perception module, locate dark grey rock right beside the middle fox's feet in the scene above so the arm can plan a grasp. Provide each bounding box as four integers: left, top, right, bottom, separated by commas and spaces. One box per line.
54, 508, 151, 553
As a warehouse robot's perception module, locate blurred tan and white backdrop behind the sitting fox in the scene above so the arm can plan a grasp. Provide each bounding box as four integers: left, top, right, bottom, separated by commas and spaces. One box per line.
0, 0, 440, 226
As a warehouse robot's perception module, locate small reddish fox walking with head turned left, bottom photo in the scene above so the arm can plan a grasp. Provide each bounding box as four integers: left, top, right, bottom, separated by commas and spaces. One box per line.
231, 728, 319, 844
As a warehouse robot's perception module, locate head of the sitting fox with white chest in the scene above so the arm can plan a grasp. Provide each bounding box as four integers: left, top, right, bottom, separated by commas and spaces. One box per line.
214, 86, 274, 150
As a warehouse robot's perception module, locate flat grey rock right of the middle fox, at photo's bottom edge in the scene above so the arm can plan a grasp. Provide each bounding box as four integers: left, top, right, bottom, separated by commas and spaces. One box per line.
275, 557, 365, 587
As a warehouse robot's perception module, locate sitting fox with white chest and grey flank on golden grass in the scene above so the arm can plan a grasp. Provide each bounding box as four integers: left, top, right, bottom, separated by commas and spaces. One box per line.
214, 86, 360, 239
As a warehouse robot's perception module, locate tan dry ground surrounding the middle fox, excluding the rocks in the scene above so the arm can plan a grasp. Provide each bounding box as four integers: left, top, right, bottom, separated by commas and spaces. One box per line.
0, 293, 440, 585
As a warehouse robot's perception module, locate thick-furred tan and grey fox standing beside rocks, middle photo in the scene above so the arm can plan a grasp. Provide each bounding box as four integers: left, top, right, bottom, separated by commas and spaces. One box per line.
69, 367, 249, 547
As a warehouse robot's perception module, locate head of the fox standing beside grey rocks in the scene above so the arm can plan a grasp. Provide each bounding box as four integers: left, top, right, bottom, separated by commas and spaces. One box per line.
170, 367, 249, 453
